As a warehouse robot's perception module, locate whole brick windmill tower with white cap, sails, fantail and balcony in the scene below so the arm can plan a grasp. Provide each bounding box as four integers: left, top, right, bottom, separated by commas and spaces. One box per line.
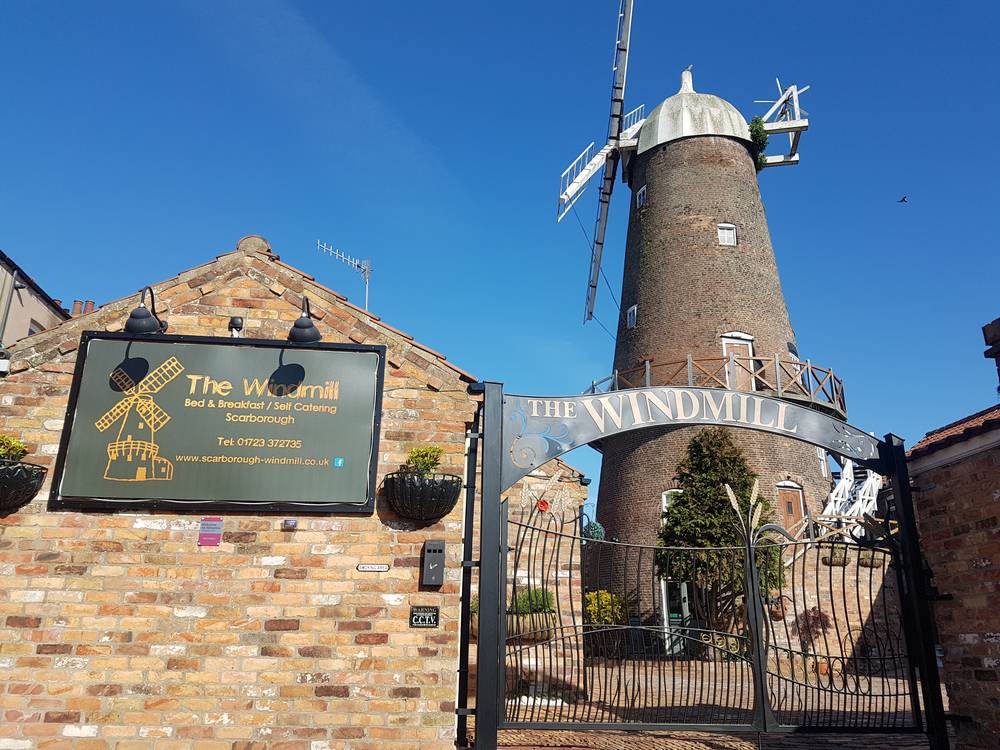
559, 0, 846, 560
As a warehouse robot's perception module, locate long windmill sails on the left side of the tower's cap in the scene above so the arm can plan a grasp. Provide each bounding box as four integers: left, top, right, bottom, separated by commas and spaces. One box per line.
556, 0, 645, 323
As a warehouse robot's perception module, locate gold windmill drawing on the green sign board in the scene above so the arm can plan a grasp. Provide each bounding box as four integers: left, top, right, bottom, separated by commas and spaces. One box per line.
94, 357, 184, 482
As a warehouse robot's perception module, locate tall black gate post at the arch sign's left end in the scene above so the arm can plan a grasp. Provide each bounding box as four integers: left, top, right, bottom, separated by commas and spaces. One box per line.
476, 382, 506, 750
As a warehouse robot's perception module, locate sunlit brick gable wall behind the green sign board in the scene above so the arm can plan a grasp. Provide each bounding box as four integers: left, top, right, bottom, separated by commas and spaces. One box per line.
0, 237, 484, 750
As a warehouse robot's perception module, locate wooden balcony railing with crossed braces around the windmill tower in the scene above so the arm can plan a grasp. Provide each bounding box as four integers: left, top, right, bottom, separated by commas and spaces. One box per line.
586, 354, 847, 419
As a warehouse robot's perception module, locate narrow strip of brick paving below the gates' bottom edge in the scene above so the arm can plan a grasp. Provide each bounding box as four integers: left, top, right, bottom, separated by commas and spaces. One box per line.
499, 730, 928, 750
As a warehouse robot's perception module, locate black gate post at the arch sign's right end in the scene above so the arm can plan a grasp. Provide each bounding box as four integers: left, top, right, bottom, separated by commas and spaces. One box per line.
879, 433, 949, 750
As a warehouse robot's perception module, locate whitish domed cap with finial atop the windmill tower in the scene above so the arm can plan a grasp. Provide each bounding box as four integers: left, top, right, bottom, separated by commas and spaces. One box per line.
638, 69, 750, 154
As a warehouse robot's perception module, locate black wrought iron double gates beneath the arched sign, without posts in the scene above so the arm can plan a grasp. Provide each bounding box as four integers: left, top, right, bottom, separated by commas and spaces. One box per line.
500, 503, 921, 732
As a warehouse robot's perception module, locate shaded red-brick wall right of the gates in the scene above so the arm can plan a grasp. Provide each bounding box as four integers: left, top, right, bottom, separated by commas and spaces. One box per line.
910, 438, 1000, 750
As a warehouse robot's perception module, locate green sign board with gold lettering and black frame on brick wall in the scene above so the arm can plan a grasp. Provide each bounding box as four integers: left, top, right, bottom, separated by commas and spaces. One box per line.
53, 332, 385, 513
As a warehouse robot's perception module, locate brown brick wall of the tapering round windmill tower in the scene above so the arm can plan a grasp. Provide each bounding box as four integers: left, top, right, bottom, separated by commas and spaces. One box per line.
598, 136, 831, 564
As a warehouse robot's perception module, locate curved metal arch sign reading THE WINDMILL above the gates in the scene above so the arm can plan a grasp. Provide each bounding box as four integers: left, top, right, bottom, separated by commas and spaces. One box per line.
501, 386, 881, 489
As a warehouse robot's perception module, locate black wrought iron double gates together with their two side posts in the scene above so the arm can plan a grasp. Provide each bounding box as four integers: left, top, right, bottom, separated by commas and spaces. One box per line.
466, 384, 948, 750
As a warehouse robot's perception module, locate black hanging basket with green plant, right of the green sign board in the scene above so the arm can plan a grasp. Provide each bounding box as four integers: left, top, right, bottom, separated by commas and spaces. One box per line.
382, 445, 462, 521
